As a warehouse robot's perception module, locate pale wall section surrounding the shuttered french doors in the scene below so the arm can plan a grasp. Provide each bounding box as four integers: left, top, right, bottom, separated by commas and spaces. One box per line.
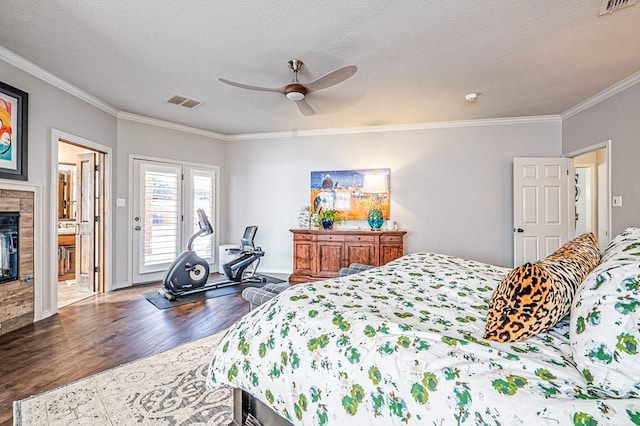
114, 119, 228, 288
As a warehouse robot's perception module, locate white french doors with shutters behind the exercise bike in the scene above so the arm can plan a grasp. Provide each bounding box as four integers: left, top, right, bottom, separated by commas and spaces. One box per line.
132, 159, 217, 284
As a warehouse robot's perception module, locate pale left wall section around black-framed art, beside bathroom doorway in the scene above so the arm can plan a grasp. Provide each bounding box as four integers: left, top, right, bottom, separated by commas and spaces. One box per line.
0, 60, 116, 313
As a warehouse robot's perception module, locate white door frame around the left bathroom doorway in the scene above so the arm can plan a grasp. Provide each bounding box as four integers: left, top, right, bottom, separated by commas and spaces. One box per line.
50, 128, 115, 313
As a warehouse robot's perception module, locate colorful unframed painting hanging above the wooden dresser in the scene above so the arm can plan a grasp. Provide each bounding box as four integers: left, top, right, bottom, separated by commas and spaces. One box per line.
309, 169, 391, 220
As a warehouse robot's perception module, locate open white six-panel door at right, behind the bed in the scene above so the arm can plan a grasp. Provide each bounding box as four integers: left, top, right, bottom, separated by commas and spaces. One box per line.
513, 158, 575, 266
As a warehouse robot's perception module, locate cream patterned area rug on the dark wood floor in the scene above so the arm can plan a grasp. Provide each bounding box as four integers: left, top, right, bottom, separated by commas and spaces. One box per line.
13, 332, 232, 426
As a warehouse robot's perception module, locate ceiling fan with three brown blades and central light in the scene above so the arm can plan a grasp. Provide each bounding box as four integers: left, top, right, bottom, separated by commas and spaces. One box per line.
220, 59, 358, 116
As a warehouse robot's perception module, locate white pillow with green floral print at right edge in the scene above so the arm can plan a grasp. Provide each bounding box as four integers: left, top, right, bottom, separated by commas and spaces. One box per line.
569, 228, 640, 398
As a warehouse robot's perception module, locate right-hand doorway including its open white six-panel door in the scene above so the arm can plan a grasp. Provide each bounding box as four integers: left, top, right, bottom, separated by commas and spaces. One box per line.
513, 141, 611, 266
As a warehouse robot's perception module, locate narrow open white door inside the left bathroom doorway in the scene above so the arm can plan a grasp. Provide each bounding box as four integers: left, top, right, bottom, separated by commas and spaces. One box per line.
76, 152, 97, 292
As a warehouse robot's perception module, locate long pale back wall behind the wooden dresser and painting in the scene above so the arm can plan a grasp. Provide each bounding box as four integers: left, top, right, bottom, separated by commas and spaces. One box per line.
227, 120, 561, 272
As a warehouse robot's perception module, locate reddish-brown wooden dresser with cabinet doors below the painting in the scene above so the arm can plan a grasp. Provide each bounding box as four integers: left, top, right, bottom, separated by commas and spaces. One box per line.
289, 229, 407, 283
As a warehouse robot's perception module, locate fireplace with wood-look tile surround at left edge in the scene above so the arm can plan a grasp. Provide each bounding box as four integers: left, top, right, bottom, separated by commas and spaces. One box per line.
0, 189, 34, 335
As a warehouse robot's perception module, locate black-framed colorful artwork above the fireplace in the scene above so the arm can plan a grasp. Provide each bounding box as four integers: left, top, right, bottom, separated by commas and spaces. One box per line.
0, 82, 29, 180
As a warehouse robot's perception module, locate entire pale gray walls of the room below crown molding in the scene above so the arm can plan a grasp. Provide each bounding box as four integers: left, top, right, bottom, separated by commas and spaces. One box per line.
5, 50, 640, 309
